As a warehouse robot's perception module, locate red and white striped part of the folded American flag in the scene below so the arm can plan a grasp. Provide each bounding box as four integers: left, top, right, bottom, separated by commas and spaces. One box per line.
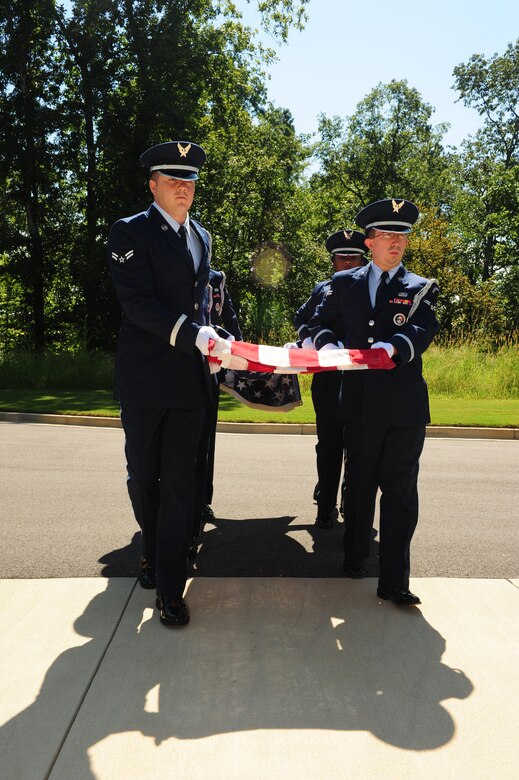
208, 340, 395, 374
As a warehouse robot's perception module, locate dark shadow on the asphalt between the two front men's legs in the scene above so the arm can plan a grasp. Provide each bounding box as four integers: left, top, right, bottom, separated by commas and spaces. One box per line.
193, 515, 378, 577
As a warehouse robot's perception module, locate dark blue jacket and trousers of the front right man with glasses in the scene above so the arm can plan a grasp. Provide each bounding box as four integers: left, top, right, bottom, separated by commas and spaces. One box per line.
310, 264, 439, 590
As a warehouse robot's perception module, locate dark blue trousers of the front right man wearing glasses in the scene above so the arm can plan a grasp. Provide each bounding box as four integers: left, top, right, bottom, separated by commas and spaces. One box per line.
344, 422, 425, 590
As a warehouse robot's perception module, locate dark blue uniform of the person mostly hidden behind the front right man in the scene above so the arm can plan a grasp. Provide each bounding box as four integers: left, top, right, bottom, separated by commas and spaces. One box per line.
294, 279, 343, 517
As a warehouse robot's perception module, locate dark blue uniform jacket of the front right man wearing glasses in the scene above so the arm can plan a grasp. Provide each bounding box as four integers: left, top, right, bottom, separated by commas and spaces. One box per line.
309, 264, 439, 426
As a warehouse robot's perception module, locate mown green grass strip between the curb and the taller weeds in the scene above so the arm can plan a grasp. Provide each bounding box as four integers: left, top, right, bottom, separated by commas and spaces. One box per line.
0, 389, 519, 428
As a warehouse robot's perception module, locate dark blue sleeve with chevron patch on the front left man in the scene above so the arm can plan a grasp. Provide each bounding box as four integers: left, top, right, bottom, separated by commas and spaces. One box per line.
108, 220, 201, 352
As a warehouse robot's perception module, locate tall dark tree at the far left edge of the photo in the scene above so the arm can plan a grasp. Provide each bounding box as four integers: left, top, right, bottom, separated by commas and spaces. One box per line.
0, 0, 66, 350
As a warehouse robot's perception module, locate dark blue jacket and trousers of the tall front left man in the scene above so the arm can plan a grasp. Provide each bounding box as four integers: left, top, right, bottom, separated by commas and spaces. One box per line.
108, 205, 211, 595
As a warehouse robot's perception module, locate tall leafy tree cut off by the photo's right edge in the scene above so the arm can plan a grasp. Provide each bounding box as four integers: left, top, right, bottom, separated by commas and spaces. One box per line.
451, 41, 519, 330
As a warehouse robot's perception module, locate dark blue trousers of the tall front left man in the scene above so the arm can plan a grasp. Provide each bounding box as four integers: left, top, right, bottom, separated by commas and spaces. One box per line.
121, 404, 205, 595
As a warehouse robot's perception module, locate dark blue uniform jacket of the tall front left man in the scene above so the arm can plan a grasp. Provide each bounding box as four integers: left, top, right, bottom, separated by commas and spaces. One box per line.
108, 205, 211, 408
